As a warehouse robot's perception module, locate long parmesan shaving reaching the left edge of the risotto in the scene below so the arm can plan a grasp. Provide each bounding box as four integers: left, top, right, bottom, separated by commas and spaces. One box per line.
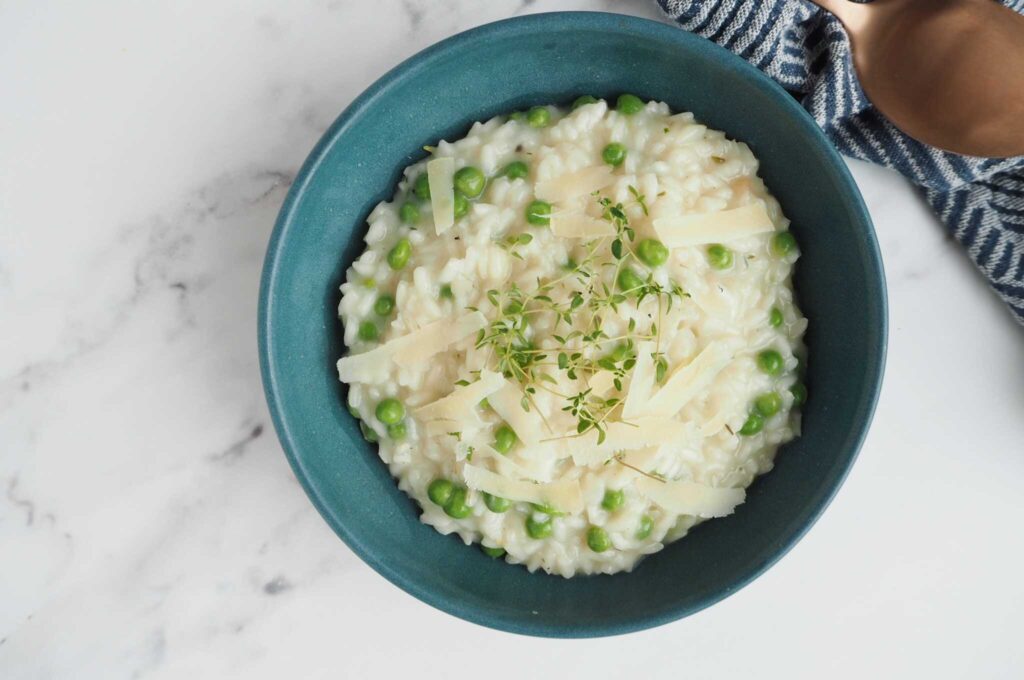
338, 311, 487, 383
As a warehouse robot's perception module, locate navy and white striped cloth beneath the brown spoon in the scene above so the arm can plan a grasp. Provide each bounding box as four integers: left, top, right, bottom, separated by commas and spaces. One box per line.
657, 0, 1024, 324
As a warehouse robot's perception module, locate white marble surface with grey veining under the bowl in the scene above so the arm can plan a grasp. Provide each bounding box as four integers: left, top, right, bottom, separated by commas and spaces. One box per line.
0, 0, 1024, 679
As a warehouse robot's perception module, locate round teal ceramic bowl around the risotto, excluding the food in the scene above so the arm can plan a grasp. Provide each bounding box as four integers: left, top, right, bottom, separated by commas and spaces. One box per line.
259, 12, 887, 637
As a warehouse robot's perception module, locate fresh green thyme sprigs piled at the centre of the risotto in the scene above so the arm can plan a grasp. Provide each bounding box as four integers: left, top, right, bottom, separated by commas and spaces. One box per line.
471, 185, 688, 443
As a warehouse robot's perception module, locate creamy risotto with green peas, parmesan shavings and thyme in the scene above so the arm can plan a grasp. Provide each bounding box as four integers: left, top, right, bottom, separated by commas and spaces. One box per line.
338, 94, 807, 577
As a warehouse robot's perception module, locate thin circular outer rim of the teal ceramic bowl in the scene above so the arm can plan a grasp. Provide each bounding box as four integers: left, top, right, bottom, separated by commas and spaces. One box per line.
256, 11, 889, 638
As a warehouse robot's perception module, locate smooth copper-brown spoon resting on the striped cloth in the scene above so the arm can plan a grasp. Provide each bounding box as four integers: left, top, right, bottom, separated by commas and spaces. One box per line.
812, 0, 1024, 158
